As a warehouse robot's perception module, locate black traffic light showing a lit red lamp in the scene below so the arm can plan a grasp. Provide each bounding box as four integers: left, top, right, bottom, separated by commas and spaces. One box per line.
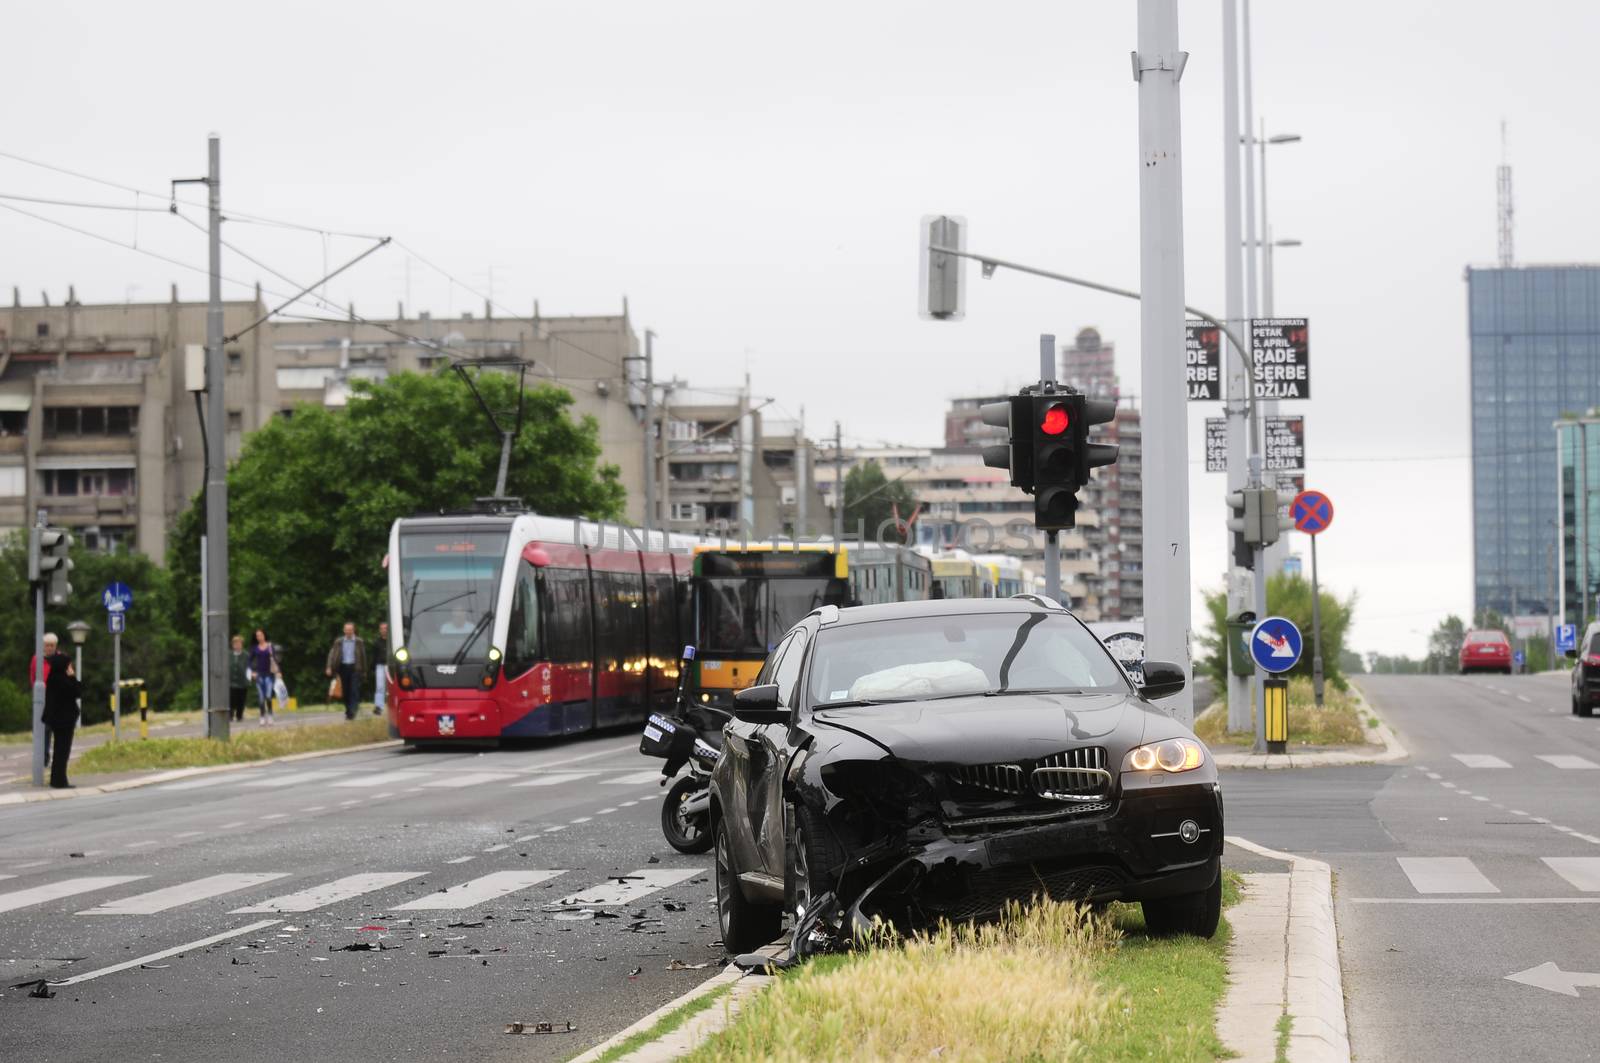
979, 389, 1117, 532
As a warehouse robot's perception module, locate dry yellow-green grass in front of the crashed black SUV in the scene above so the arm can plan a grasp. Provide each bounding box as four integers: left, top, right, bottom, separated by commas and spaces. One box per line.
688, 872, 1240, 1063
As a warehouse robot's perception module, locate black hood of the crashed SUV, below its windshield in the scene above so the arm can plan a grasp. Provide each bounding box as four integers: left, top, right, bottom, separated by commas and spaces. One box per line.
811, 693, 1166, 764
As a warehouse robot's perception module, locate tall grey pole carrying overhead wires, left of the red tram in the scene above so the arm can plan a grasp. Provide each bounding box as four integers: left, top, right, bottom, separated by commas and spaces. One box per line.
205, 133, 229, 741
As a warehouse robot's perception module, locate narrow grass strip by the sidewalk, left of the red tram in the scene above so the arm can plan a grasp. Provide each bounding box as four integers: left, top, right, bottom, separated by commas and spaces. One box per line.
72, 716, 389, 775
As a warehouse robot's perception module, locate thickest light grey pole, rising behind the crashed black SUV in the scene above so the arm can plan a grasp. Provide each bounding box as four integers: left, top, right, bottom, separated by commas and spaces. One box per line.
1133, 0, 1194, 725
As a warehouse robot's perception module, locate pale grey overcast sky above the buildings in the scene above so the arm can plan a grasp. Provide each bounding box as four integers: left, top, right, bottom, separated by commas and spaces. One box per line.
0, 0, 1600, 653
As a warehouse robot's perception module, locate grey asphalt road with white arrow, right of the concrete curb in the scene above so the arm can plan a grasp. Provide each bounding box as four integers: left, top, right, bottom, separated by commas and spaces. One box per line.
1222, 676, 1600, 1061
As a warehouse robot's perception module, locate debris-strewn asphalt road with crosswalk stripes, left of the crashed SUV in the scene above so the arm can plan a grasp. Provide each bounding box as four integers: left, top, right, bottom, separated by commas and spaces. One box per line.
0, 732, 722, 1063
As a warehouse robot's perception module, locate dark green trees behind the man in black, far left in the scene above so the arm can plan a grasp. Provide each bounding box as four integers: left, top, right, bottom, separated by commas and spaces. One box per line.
0, 532, 188, 730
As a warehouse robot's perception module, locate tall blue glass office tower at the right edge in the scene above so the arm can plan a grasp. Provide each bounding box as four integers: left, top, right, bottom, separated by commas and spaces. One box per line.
1467, 266, 1600, 623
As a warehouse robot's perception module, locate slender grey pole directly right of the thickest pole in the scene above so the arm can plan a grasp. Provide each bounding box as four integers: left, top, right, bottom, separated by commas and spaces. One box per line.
1218, 0, 1254, 732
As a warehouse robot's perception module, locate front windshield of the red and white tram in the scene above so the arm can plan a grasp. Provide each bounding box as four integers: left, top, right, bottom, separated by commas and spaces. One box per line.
400, 528, 507, 663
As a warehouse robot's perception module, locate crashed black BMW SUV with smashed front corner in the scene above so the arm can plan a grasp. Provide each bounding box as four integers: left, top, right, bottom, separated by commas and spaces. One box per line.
710, 596, 1222, 953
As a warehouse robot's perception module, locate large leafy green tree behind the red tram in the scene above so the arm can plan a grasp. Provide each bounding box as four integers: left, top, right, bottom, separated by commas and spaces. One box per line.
168, 373, 624, 700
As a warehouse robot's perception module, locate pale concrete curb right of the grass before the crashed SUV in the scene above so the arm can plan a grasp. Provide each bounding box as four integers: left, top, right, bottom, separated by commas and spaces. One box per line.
1218, 836, 1350, 1063
